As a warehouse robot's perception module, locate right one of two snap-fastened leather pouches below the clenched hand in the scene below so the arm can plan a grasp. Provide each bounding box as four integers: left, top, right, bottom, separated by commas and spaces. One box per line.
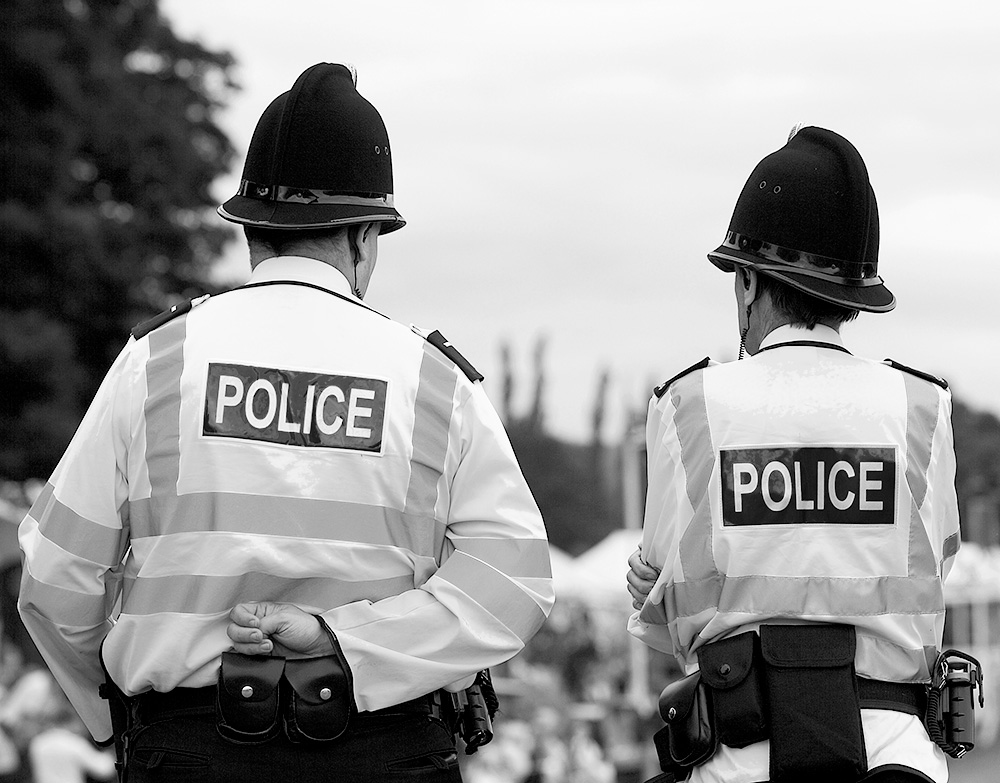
285, 655, 354, 742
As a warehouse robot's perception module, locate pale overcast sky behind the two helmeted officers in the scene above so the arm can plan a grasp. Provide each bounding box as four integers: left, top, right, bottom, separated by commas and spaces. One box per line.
161, 0, 1000, 443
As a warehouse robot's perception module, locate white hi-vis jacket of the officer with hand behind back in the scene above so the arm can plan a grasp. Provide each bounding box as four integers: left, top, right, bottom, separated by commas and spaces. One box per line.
20, 257, 554, 739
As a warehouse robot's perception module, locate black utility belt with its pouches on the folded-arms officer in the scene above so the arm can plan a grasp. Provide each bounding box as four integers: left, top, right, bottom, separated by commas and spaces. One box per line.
654, 625, 908, 783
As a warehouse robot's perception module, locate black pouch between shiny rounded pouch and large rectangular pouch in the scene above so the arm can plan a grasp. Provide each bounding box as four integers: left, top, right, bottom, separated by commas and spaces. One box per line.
698, 631, 768, 748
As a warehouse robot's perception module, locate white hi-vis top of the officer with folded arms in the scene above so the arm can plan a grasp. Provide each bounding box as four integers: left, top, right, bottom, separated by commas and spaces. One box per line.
629, 326, 959, 783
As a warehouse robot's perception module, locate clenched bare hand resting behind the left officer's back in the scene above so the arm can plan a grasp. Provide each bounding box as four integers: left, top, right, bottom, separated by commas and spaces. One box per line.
226, 601, 334, 658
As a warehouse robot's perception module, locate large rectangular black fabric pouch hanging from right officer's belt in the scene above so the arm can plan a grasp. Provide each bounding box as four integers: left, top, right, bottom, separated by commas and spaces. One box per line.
760, 625, 868, 783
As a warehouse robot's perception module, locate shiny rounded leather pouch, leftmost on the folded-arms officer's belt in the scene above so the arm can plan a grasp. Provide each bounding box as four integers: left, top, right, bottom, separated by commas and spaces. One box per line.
653, 672, 718, 772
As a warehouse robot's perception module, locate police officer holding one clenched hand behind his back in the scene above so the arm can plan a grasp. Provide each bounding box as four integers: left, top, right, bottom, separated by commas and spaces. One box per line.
20, 63, 553, 783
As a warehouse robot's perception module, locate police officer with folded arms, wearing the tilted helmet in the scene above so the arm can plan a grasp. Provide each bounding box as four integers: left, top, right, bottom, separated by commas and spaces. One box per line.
628, 127, 959, 783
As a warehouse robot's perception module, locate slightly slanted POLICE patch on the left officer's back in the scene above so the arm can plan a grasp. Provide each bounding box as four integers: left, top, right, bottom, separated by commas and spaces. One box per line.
202, 362, 388, 453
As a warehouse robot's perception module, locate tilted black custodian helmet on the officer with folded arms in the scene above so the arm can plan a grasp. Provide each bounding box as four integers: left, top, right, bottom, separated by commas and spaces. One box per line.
708, 127, 896, 313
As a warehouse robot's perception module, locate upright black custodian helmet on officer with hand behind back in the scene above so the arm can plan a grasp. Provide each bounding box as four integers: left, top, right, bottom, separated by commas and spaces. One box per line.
219, 63, 405, 234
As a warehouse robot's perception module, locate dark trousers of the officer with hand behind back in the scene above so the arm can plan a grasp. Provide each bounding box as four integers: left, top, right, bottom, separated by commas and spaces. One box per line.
128, 709, 462, 783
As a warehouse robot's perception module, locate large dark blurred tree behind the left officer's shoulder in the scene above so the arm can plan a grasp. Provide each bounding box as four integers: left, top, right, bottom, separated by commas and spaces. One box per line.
0, 0, 236, 479
